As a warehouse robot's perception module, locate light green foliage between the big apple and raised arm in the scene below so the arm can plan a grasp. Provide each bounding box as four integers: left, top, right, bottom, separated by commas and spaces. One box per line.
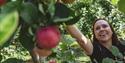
50, 35, 90, 63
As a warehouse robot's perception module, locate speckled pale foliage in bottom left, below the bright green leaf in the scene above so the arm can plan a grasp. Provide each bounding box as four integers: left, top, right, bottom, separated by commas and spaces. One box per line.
0, 35, 31, 63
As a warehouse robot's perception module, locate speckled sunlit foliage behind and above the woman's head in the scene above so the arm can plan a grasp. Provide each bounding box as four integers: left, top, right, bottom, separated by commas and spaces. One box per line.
72, 0, 125, 38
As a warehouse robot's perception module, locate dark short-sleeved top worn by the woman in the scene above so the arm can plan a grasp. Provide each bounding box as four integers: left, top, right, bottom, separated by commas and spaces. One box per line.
90, 43, 125, 63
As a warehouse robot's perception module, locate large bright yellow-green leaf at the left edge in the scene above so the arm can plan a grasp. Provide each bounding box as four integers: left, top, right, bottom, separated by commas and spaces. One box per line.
0, 11, 19, 46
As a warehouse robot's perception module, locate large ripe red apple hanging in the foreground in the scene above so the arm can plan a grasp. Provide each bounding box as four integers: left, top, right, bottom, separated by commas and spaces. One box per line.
36, 26, 60, 49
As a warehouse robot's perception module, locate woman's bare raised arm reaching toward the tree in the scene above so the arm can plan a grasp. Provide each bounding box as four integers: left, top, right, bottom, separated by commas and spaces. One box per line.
66, 25, 93, 55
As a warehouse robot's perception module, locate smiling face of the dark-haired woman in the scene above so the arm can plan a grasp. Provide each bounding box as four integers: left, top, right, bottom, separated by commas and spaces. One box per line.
94, 20, 113, 42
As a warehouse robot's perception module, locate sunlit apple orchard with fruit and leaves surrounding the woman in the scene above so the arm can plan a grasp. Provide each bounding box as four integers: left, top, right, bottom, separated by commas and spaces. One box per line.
0, 0, 125, 63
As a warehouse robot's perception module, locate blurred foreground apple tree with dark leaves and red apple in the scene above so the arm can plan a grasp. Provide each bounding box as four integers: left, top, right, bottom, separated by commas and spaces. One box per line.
0, 0, 80, 63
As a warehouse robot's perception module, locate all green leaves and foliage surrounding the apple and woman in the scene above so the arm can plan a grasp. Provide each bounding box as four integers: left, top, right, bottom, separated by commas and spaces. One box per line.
0, 0, 125, 63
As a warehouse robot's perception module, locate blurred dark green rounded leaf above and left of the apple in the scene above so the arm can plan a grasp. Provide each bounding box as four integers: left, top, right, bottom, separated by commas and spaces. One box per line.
20, 2, 38, 24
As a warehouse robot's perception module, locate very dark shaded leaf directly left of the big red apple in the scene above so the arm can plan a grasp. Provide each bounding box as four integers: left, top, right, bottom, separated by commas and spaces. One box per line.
19, 23, 34, 51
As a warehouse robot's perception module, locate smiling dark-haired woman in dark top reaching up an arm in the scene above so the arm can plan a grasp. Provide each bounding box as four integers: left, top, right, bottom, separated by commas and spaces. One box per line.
67, 19, 125, 63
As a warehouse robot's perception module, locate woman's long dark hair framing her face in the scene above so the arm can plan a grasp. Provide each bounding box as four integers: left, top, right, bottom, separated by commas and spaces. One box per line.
92, 18, 120, 45
